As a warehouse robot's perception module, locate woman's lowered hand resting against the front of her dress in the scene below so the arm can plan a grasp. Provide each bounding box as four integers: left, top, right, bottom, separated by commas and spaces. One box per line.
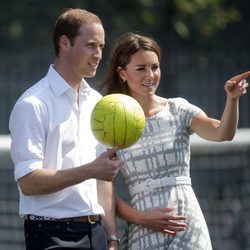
140, 208, 187, 235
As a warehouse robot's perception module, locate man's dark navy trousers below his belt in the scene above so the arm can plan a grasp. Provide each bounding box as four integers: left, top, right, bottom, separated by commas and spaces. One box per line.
24, 220, 108, 250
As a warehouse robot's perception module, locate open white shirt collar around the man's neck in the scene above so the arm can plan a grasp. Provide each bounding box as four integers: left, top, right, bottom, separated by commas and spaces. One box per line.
47, 64, 91, 97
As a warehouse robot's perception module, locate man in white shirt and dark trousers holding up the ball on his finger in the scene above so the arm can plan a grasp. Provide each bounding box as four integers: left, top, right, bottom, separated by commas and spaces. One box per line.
9, 9, 122, 250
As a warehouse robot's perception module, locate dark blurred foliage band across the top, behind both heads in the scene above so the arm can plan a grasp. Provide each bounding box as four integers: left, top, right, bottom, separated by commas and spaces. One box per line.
0, 0, 246, 51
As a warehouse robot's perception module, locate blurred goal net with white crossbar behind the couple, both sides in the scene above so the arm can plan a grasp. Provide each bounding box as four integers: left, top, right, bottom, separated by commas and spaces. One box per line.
0, 129, 250, 250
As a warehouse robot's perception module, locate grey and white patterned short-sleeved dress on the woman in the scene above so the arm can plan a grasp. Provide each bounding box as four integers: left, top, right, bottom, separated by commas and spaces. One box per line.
118, 97, 212, 250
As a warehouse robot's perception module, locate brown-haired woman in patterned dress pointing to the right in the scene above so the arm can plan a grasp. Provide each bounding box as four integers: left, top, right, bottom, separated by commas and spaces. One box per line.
102, 33, 250, 250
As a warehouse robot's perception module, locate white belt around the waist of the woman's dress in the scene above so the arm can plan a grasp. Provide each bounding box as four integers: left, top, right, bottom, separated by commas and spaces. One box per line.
129, 176, 191, 196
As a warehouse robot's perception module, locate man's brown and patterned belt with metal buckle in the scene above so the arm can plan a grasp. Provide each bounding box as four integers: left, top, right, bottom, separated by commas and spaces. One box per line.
24, 214, 101, 224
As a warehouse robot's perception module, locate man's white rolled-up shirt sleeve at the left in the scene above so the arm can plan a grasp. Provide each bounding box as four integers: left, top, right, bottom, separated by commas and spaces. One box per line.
9, 97, 46, 180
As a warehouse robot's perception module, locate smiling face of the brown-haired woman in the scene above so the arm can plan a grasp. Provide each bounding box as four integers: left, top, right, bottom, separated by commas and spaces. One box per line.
119, 50, 161, 97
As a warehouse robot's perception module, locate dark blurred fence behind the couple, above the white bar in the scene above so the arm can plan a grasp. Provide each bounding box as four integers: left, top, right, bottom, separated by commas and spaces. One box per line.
0, 51, 250, 134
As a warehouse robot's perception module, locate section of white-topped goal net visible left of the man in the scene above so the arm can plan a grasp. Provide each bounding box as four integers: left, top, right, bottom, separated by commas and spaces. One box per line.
0, 136, 25, 250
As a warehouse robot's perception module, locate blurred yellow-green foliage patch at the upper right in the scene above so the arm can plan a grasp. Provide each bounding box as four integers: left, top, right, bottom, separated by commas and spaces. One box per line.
173, 0, 241, 39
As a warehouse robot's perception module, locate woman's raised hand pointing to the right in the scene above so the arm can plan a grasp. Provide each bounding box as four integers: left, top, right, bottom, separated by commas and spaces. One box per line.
225, 71, 250, 99
